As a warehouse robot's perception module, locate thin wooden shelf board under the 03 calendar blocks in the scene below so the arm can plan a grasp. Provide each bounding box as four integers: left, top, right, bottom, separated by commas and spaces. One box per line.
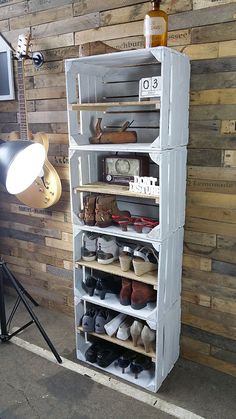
70, 100, 160, 111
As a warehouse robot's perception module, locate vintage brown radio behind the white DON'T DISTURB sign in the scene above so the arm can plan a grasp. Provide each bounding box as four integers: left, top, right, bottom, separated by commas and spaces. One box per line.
103, 155, 149, 185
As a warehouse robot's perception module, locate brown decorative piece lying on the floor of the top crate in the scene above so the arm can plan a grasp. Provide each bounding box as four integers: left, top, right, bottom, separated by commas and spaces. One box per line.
89, 118, 137, 144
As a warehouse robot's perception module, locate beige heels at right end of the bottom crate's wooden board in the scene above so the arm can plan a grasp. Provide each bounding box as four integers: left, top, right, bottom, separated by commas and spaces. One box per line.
130, 320, 156, 353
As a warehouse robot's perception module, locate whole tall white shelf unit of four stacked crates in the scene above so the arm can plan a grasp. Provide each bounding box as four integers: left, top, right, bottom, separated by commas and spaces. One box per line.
65, 47, 190, 392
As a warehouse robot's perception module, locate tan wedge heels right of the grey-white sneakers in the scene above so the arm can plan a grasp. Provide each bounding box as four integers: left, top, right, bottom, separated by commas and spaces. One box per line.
119, 246, 158, 276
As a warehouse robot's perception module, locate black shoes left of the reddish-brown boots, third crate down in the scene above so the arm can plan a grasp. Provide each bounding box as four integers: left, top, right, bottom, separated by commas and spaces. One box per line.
83, 275, 121, 300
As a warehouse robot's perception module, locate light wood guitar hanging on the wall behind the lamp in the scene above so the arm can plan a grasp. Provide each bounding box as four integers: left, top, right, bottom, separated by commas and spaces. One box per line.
10, 34, 61, 208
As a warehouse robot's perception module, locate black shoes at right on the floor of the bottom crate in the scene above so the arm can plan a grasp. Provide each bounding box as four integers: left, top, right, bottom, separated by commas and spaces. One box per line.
117, 351, 153, 379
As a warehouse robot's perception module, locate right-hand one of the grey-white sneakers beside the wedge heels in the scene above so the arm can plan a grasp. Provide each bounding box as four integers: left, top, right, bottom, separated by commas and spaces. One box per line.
97, 236, 119, 265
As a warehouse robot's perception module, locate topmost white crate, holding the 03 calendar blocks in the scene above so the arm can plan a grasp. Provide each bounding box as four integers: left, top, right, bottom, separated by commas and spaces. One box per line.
65, 47, 190, 149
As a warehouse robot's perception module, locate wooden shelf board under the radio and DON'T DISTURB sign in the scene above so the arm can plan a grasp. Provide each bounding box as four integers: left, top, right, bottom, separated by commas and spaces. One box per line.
74, 182, 160, 203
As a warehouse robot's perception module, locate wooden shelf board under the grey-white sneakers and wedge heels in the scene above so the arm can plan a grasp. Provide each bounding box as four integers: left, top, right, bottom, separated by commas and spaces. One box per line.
76, 260, 157, 289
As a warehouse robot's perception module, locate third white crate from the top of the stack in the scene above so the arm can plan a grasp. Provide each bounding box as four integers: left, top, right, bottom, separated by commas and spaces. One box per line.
73, 226, 184, 329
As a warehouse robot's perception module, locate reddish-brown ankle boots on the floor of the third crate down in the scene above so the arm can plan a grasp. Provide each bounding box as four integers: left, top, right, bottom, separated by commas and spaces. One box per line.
131, 281, 157, 310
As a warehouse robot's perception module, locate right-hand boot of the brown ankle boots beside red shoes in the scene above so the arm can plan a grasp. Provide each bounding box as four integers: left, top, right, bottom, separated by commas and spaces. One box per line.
95, 195, 130, 228
